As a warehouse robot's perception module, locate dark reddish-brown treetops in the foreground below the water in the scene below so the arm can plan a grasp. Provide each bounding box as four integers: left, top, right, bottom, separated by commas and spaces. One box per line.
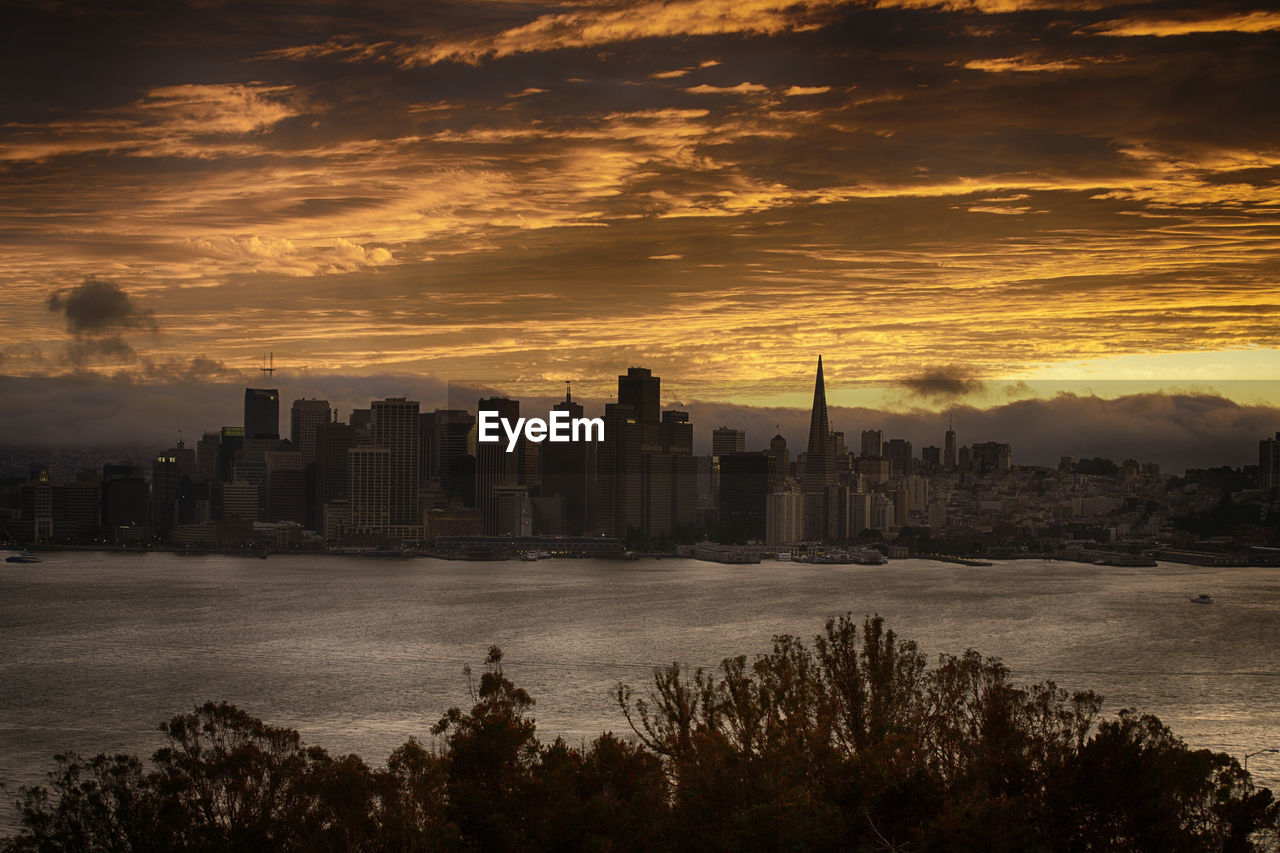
0, 616, 1277, 853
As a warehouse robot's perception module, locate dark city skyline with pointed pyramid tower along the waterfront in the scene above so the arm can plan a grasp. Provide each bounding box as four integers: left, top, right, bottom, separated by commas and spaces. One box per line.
0, 356, 1280, 565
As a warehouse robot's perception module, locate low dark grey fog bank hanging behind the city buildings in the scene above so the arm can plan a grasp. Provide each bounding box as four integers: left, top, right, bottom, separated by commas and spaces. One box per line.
0, 360, 1280, 470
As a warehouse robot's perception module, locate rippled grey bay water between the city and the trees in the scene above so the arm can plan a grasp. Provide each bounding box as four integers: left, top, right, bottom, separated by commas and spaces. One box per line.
0, 553, 1280, 824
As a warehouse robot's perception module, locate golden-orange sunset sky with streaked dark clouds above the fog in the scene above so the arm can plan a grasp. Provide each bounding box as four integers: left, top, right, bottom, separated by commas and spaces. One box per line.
0, 0, 1280, 447
